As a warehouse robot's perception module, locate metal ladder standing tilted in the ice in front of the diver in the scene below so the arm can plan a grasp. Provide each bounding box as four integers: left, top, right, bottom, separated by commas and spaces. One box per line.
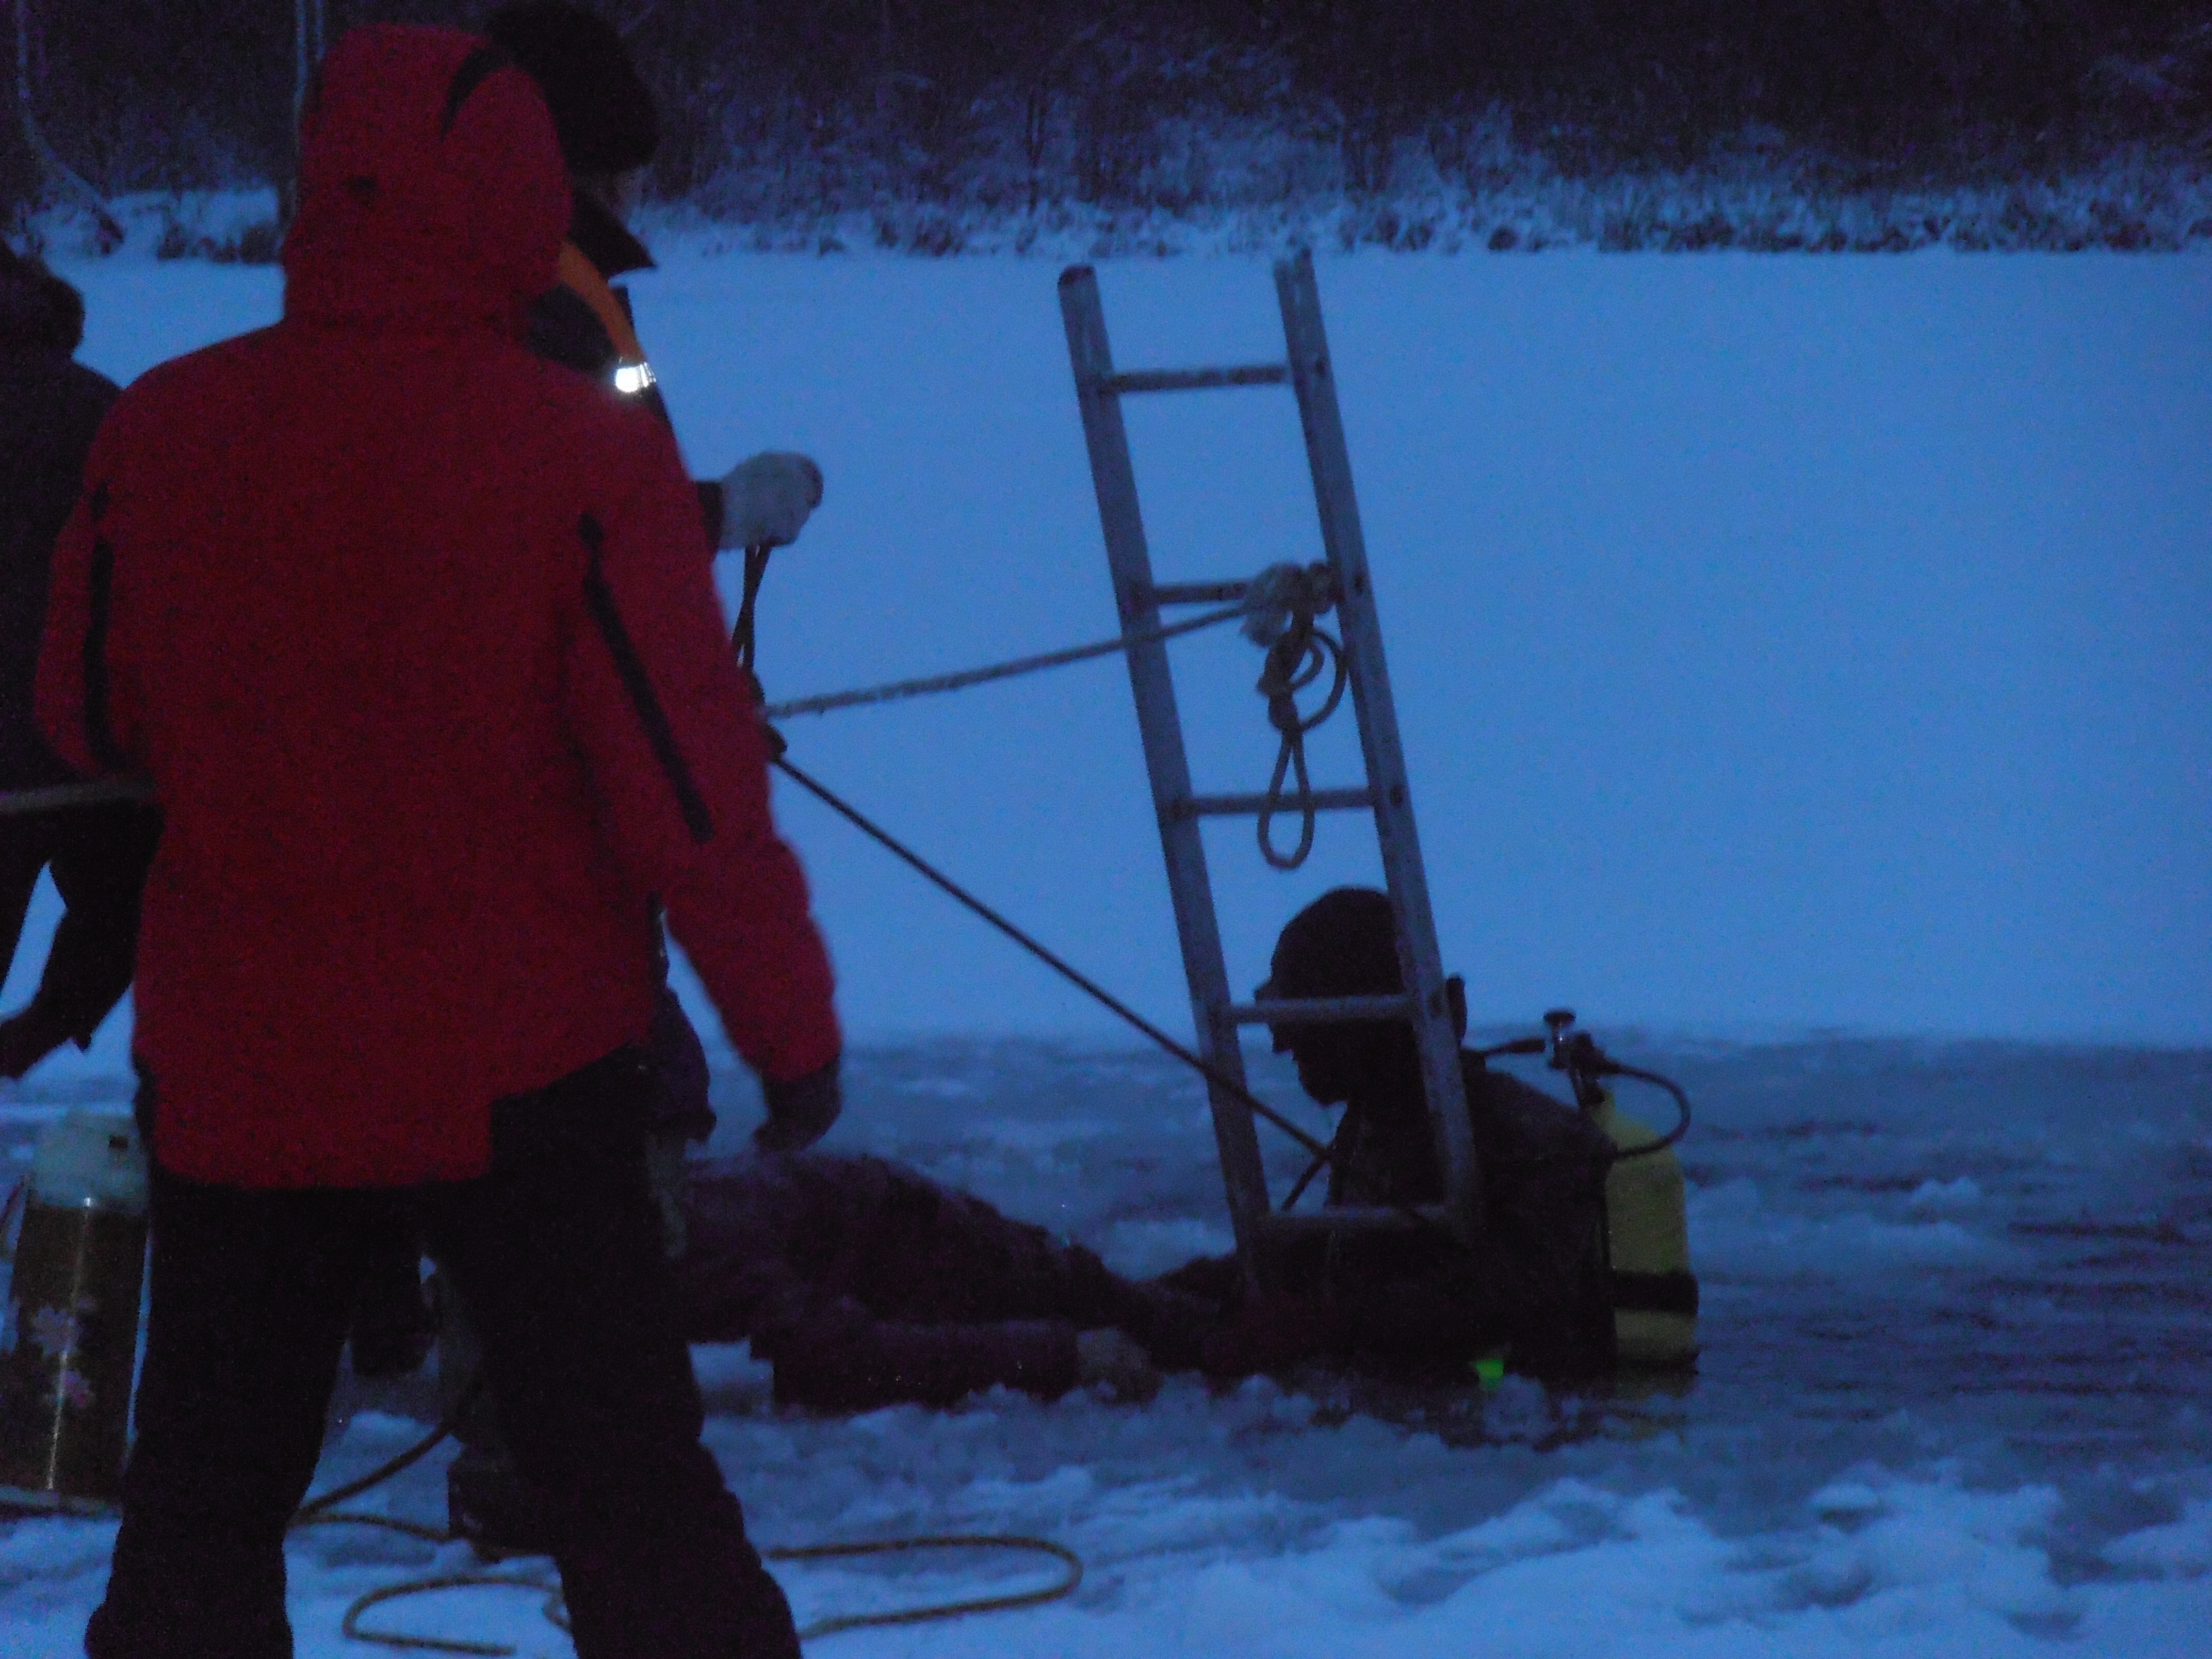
1060, 250, 1482, 1278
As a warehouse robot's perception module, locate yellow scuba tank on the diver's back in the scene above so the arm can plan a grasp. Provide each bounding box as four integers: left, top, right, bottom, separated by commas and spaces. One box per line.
1590, 1088, 1697, 1372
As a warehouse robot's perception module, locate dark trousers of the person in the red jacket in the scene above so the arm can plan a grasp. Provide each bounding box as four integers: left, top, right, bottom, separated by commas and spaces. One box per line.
86, 1051, 799, 1659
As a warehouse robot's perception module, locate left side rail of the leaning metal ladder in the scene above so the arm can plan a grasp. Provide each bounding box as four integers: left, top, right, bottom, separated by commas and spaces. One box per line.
1060, 266, 1272, 1281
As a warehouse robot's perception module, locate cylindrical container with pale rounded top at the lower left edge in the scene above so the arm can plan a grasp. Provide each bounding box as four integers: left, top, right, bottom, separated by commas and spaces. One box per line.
0, 1111, 146, 1511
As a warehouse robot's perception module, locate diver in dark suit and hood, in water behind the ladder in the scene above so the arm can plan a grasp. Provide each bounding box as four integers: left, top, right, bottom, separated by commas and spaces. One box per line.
1161, 887, 1613, 1382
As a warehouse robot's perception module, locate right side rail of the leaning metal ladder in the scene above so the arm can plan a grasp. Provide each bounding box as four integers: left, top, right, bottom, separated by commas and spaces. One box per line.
1274, 250, 1482, 1239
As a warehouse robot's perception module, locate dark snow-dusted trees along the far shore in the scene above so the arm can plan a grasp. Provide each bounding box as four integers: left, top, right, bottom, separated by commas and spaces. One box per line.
0, 0, 2212, 224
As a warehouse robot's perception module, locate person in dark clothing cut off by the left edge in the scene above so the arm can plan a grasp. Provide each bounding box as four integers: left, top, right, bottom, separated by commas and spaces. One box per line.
0, 243, 161, 1077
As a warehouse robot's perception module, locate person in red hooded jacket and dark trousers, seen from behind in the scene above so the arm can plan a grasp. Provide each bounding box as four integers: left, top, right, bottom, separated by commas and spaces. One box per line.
38, 26, 840, 1659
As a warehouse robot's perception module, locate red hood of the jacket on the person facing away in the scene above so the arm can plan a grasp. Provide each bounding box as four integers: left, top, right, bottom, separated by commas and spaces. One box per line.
283, 24, 568, 332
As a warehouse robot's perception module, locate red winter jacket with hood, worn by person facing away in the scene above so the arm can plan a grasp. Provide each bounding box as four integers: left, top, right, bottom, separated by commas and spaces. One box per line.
38, 26, 838, 1188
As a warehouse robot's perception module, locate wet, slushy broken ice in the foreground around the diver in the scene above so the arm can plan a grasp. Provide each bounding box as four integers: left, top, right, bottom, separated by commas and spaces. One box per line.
0, 1033, 2212, 1659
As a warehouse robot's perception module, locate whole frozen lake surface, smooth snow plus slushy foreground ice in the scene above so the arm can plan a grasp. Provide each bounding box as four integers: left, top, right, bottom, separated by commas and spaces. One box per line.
0, 252, 2212, 1659
